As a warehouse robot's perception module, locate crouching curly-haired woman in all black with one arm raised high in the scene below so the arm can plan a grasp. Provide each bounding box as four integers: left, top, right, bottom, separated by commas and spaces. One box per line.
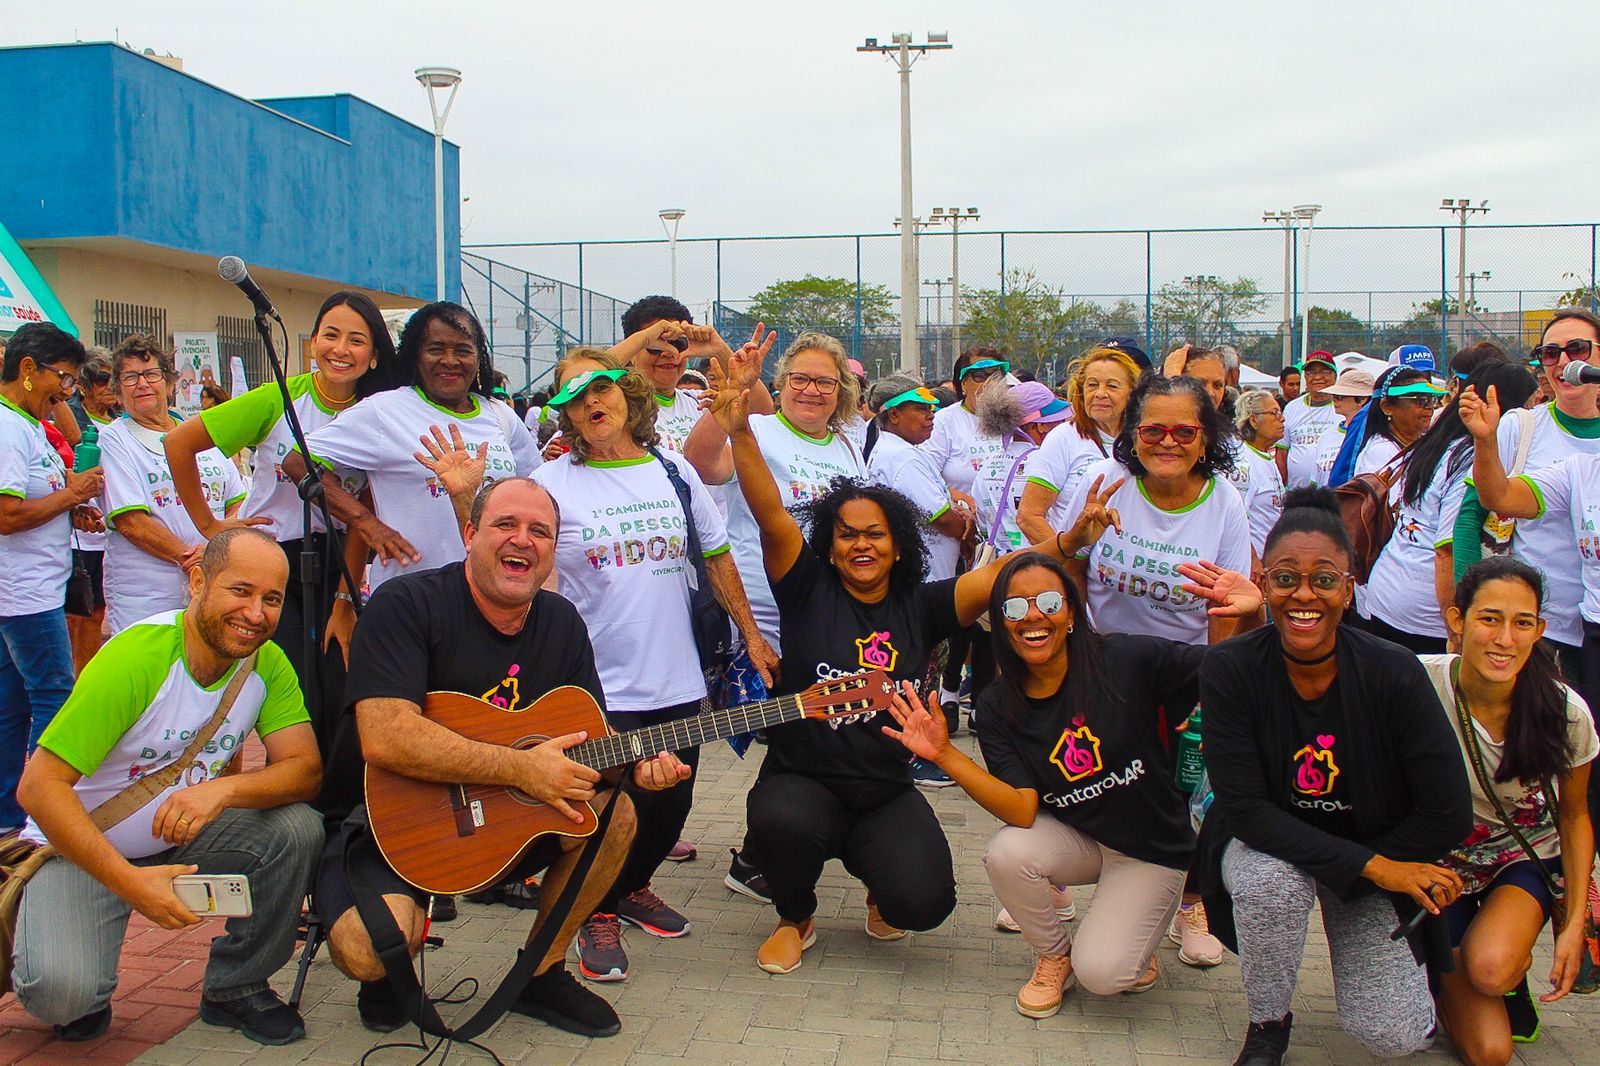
710, 371, 1113, 973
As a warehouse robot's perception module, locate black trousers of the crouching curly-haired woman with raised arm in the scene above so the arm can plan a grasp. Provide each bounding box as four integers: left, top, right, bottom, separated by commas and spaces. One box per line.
746, 773, 955, 930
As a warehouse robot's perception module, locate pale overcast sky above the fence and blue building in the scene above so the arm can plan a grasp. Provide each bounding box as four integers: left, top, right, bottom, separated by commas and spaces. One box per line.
15, 0, 1600, 316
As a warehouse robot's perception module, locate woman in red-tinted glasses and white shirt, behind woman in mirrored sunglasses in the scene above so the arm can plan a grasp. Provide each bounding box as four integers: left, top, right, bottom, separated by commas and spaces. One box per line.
1067, 369, 1250, 643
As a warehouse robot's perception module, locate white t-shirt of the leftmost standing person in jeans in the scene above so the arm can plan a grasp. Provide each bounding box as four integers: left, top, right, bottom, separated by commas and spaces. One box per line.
0, 393, 72, 618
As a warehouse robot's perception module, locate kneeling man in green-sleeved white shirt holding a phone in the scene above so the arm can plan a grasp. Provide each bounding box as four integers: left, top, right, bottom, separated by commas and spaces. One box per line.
13, 528, 323, 1044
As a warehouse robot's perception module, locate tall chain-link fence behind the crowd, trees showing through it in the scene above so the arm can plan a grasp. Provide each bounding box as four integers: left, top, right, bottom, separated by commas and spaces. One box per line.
462, 222, 1600, 393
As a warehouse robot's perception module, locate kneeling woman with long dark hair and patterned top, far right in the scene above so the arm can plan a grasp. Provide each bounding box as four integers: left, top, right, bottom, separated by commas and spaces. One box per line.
1422, 555, 1600, 1066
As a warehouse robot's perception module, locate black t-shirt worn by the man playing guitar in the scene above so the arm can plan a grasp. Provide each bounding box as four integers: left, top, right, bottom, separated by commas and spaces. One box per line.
323, 562, 605, 815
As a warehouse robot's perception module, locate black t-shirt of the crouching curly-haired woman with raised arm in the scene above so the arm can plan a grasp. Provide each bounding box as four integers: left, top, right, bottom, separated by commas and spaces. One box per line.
762, 547, 960, 792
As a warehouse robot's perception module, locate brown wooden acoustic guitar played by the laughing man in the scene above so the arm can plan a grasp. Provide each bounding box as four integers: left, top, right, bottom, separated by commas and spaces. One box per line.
366, 671, 894, 895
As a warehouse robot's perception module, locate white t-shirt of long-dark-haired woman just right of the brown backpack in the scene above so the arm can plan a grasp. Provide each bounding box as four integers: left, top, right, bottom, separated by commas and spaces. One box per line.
1355, 439, 1472, 639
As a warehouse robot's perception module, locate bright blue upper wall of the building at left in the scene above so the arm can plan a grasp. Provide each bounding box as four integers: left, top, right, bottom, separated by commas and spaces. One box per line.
0, 43, 461, 299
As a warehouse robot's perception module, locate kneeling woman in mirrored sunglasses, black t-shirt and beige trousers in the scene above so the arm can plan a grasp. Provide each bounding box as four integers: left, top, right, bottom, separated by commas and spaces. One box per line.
883, 557, 1261, 1018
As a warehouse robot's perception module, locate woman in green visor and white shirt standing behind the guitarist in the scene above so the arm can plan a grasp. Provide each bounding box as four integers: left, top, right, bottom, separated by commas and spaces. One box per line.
533, 347, 778, 981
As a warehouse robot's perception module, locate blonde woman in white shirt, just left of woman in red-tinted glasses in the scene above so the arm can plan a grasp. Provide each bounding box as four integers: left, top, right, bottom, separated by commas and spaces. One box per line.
1016, 347, 1144, 541
